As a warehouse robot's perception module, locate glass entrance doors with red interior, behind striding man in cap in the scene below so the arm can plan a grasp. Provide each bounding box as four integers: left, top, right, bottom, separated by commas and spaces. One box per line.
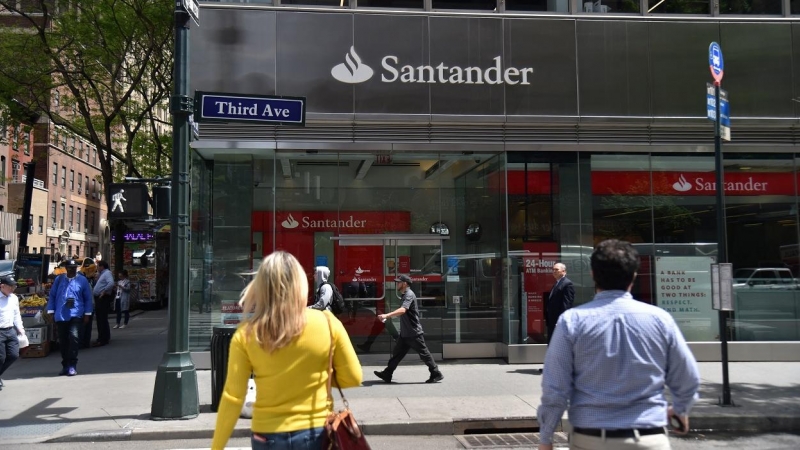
331, 234, 449, 362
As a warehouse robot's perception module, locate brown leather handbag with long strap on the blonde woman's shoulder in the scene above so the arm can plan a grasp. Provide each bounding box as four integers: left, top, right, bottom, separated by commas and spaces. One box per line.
322, 314, 371, 450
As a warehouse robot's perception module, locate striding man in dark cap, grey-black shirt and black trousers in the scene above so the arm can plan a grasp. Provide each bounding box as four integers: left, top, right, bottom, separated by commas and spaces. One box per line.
375, 275, 444, 383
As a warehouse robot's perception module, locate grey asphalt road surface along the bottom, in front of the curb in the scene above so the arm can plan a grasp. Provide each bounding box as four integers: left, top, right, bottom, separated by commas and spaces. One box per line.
9, 433, 800, 450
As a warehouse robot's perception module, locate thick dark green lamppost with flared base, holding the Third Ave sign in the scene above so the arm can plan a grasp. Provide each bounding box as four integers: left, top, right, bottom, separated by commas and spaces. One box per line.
150, 7, 200, 420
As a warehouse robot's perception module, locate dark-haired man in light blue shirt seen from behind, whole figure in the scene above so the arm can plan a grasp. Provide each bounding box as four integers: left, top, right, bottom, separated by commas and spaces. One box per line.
538, 239, 700, 450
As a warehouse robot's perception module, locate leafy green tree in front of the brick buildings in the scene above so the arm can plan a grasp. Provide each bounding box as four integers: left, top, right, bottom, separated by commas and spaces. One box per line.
0, 0, 174, 267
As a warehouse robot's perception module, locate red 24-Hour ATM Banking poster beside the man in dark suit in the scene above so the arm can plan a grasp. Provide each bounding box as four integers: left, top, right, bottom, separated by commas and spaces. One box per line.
522, 242, 558, 343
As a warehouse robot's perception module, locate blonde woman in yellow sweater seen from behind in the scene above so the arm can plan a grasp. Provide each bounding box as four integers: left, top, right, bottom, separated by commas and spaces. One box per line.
211, 251, 362, 450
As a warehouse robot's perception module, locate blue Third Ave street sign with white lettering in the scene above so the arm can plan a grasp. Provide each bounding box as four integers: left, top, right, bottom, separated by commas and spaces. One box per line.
194, 91, 306, 125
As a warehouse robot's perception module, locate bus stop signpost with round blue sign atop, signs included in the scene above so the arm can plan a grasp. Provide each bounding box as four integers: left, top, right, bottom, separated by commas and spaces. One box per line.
706, 42, 733, 406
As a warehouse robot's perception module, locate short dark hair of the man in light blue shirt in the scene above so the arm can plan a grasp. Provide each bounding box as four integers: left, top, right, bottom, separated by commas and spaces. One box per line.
592, 239, 639, 291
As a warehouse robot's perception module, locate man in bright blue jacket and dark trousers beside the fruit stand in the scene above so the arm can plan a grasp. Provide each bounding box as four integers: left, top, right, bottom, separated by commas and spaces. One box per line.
47, 259, 92, 377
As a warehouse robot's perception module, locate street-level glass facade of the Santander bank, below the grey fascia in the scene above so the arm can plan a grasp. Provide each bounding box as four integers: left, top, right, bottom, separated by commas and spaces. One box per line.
190, 150, 800, 355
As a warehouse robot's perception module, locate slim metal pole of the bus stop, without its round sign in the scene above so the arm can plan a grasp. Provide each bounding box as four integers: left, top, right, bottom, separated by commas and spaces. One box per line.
714, 82, 732, 406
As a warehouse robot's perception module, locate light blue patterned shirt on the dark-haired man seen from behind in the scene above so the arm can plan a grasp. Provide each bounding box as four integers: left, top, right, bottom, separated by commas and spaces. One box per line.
538, 291, 700, 444
